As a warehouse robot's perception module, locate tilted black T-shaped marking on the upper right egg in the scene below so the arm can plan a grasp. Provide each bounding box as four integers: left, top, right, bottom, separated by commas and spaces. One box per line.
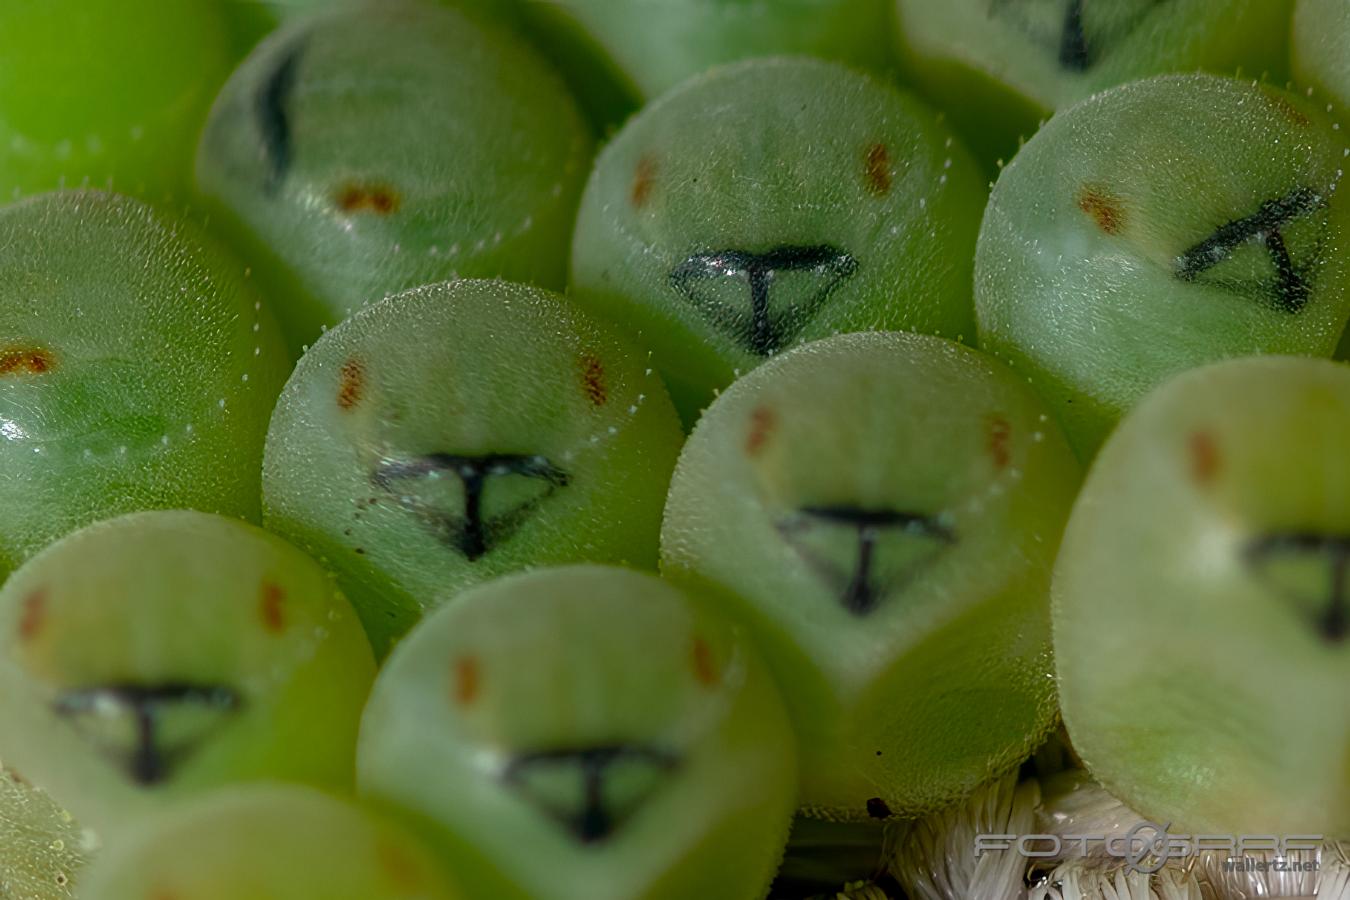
1176, 188, 1326, 313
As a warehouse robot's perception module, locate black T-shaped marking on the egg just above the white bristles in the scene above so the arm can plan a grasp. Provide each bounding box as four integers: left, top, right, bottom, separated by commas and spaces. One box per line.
778, 506, 956, 617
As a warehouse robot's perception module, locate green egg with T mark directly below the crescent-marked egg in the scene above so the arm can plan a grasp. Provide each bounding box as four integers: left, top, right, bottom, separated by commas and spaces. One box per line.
263, 281, 683, 653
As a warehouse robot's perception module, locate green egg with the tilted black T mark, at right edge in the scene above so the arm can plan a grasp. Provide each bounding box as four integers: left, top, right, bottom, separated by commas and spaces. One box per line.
975, 76, 1350, 457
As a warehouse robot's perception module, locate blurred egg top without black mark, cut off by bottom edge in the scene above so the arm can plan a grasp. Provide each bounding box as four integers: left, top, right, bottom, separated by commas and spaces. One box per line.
82, 785, 459, 900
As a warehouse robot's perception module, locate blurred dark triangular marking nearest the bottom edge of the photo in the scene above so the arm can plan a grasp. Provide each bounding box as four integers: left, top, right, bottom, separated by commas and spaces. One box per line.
502, 743, 678, 843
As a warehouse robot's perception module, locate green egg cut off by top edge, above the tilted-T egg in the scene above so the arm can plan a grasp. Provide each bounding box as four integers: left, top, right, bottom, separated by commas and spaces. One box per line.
896, 0, 1292, 161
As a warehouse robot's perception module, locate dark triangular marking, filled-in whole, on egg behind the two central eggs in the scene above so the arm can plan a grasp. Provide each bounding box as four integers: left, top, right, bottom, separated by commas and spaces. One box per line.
670, 246, 857, 356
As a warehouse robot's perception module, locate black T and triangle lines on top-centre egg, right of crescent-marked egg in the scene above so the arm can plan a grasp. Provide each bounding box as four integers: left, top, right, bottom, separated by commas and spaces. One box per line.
670, 244, 857, 356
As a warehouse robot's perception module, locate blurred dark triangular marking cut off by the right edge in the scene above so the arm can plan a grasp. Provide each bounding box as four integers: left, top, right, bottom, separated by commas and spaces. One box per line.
1243, 532, 1350, 644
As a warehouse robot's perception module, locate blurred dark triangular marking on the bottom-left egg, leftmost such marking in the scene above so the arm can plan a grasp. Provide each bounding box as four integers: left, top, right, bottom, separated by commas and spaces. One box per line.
54, 683, 240, 785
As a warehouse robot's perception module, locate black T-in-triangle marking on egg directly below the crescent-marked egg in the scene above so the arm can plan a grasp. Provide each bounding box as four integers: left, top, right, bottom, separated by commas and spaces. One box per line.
371, 453, 570, 561
